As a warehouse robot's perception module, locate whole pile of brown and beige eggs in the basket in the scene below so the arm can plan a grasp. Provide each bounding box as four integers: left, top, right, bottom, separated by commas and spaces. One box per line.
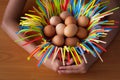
43, 11, 90, 46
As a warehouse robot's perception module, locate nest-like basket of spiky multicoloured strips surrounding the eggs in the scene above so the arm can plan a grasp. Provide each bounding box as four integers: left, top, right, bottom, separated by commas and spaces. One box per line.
16, 0, 119, 66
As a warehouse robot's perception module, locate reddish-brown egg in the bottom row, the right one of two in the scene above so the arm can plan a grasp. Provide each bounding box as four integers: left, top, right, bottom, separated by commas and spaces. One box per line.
65, 37, 79, 46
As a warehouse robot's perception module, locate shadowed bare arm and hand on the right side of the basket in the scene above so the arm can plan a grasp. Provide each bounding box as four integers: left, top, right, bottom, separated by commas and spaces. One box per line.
58, 0, 120, 74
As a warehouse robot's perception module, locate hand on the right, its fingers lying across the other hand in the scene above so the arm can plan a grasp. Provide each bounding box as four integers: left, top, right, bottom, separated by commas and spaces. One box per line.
58, 54, 97, 74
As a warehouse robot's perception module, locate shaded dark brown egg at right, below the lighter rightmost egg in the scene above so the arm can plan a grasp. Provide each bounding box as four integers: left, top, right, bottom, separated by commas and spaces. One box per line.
76, 27, 88, 39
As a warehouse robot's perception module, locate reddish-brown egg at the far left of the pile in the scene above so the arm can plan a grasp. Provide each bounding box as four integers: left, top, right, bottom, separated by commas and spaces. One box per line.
44, 25, 56, 37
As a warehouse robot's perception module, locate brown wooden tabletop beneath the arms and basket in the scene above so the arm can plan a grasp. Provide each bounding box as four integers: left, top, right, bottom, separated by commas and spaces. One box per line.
0, 0, 120, 80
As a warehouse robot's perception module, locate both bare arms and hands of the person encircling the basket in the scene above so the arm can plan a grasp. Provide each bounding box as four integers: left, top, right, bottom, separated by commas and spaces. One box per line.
2, 0, 120, 74
